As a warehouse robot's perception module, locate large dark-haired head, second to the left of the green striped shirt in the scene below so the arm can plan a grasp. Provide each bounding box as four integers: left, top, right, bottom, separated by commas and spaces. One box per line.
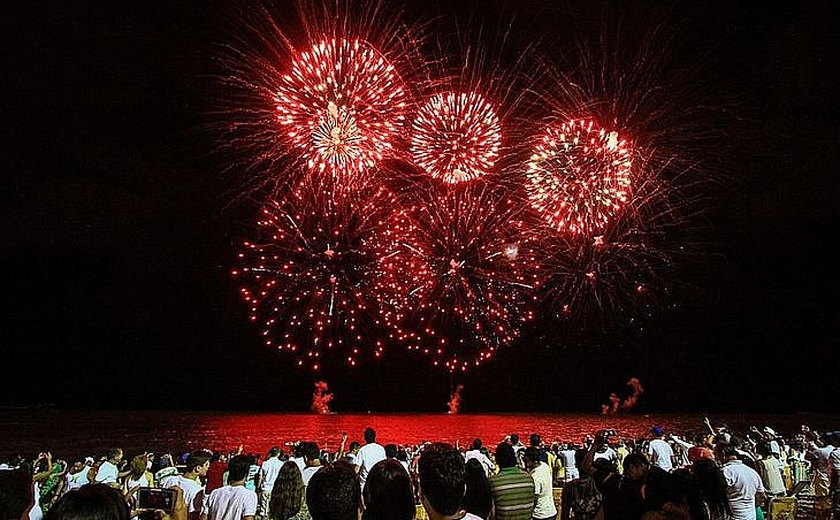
417, 442, 466, 516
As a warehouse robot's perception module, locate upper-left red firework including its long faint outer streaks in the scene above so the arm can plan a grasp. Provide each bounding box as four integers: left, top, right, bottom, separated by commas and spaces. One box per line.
220, 0, 421, 192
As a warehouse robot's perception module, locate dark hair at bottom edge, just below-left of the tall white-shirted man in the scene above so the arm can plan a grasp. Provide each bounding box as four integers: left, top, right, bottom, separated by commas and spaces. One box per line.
306, 461, 362, 520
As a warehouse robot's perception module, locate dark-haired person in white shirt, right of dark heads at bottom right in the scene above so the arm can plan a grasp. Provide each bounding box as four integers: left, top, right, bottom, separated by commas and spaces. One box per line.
715, 442, 764, 520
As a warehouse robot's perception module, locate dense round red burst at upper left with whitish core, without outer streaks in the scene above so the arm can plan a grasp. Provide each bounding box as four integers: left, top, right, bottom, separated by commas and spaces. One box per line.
274, 38, 407, 177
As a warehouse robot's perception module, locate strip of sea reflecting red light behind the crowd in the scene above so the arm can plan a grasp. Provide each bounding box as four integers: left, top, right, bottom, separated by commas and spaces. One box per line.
0, 409, 840, 460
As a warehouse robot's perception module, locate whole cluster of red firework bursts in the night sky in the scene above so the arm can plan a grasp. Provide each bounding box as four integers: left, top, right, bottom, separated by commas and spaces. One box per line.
226, 2, 720, 371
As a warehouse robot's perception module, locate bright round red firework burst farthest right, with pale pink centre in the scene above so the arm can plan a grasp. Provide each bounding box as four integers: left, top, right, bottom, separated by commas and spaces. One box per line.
526, 119, 632, 236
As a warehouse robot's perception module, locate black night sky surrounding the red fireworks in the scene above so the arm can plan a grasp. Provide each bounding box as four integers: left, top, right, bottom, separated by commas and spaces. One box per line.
0, 0, 840, 411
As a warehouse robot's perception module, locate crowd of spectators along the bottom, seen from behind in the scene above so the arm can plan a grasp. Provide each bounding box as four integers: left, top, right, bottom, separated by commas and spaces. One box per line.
0, 419, 840, 520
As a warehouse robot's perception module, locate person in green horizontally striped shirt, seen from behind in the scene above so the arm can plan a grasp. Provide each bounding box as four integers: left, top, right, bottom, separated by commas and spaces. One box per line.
489, 442, 536, 520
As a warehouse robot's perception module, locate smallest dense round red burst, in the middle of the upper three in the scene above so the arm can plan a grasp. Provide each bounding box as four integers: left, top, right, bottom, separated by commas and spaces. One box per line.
411, 92, 502, 184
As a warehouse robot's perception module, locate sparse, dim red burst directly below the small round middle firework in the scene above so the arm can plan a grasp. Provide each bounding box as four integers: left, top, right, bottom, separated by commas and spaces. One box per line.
391, 185, 537, 370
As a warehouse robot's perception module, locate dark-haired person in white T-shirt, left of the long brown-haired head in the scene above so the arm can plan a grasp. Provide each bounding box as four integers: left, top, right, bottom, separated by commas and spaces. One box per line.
201, 455, 257, 520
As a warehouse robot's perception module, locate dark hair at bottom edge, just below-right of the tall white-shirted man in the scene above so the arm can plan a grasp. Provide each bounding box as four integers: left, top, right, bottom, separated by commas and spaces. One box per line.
362, 459, 416, 520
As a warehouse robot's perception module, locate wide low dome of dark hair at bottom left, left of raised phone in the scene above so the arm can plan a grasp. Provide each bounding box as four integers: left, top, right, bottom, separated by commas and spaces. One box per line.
44, 484, 131, 520
